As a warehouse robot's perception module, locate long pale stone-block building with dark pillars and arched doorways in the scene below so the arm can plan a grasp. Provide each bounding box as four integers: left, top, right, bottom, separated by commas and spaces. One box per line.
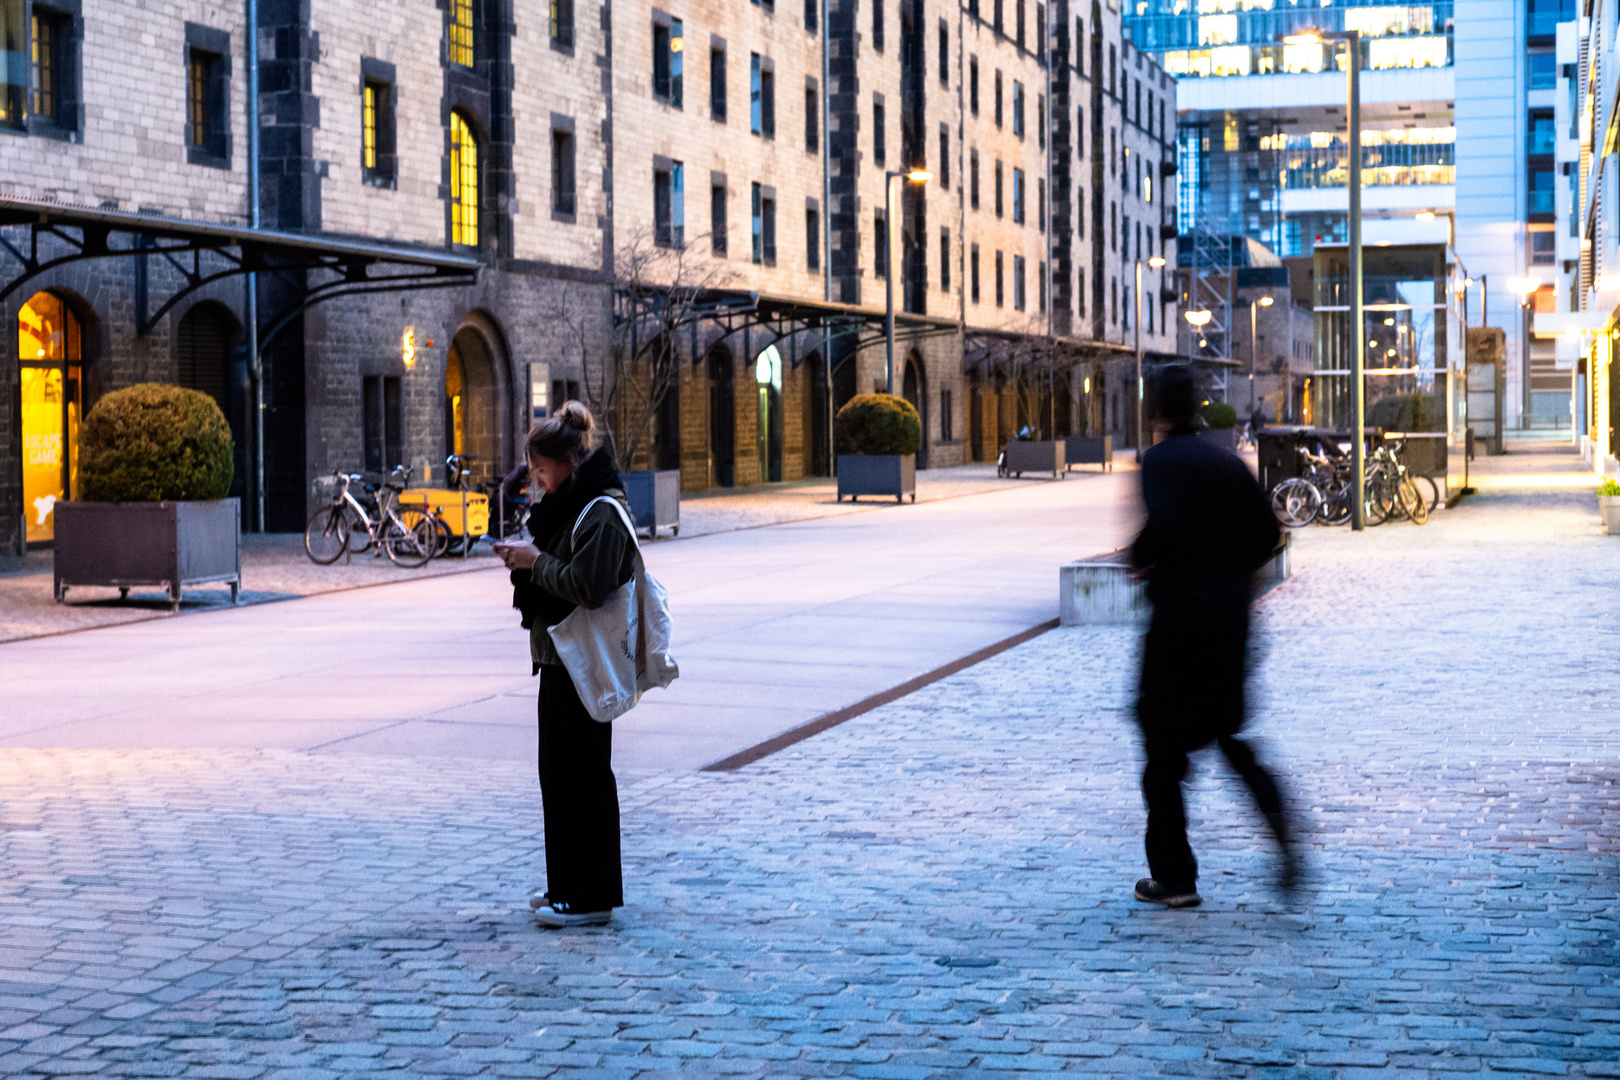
0, 0, 1176, 552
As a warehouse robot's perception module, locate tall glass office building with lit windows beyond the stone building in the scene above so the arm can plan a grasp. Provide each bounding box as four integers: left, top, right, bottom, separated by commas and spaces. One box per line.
1126, 0, 1456, 256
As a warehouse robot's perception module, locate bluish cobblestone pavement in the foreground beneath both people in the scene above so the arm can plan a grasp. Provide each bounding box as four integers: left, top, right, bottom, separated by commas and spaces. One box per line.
0, 479, 1620, 1080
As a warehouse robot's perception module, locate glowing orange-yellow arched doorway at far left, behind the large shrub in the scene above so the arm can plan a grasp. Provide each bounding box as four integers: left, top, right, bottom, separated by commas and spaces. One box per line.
16, 293, 84, 544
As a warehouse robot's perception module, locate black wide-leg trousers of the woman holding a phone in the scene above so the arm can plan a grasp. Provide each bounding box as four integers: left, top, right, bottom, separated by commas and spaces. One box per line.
539, 664, 624, 912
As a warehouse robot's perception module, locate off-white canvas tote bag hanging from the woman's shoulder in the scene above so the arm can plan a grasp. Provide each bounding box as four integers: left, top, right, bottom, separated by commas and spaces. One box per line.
548, 495, 680, 724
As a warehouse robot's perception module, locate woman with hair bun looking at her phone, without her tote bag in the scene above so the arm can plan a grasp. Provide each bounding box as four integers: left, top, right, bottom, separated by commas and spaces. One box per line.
496, 402, 635, 926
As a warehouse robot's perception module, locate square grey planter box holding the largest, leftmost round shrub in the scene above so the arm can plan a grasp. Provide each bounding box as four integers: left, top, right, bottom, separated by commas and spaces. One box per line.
55, 499, 241, 610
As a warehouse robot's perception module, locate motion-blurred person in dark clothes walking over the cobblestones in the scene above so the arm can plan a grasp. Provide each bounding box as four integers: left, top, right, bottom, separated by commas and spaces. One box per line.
1131, 364, 1299, 907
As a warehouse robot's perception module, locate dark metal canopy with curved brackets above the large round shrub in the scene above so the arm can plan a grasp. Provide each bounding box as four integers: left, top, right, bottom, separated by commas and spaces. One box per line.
0, 198, 481, 342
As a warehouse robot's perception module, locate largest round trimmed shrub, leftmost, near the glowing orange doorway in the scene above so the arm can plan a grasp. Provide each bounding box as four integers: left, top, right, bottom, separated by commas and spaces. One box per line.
79, 382, 233, 502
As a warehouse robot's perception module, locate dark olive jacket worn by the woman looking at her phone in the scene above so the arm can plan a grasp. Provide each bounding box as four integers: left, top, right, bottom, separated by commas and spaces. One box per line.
528, 487, 637, 670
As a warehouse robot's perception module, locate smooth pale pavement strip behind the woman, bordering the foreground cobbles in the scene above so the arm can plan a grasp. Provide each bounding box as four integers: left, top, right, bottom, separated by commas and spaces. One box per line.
0, 471, 1137, 771
